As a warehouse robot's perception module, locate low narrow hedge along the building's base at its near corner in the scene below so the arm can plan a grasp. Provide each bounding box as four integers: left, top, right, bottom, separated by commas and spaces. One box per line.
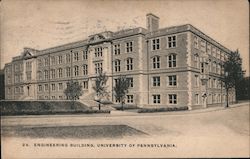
138, 106, 188, 113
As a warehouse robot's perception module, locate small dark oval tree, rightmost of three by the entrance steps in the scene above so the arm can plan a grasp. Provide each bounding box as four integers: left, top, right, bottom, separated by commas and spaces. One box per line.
114, 76, 129, 110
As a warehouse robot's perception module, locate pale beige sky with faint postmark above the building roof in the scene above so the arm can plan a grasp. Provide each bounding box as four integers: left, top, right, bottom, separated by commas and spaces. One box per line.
0, 0, 249, 76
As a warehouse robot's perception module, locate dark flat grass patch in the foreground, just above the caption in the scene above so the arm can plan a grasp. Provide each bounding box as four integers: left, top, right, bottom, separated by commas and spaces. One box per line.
2, 125, 146, 139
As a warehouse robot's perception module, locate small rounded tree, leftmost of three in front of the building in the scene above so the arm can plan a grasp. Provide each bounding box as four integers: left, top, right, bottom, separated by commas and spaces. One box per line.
64, 80, 83, 107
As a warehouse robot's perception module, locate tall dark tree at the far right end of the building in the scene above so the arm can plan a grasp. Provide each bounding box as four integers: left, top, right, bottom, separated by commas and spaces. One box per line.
222, 50, 243, 107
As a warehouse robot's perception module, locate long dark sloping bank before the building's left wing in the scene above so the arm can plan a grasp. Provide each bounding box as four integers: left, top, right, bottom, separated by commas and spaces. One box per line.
0, 101, 110, 116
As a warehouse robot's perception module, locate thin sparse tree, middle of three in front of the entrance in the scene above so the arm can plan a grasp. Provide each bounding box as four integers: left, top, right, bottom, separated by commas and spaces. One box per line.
93, 71, 109, 110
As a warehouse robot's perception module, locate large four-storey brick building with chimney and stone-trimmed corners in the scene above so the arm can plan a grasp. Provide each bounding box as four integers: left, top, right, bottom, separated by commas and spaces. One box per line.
5, 13, 234, 109
